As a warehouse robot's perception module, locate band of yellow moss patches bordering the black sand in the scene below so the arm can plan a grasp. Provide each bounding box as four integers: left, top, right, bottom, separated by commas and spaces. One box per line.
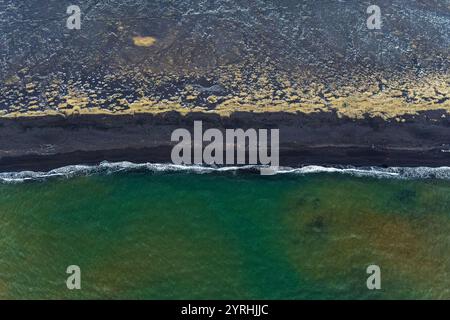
0, 66, 450, 122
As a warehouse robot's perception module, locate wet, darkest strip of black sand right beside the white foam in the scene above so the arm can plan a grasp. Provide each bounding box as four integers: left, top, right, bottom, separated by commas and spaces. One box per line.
0, 147, 450, 173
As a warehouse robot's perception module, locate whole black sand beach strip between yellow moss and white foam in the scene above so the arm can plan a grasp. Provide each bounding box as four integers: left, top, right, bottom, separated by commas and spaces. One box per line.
0, 110, 450, 172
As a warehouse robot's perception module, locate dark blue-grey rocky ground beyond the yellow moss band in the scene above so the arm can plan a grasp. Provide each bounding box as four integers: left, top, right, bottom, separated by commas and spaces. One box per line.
0, 0, 450, 79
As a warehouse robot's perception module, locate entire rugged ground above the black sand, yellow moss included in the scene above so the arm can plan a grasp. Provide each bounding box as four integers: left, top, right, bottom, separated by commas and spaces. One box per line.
0, 0, 450, 121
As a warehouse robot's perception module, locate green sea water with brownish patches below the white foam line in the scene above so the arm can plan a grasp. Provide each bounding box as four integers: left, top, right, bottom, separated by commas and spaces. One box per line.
0, 172, 450, 299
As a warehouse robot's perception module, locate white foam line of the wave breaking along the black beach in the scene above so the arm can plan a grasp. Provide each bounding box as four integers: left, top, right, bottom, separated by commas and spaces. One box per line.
0, 161, 450, 183
